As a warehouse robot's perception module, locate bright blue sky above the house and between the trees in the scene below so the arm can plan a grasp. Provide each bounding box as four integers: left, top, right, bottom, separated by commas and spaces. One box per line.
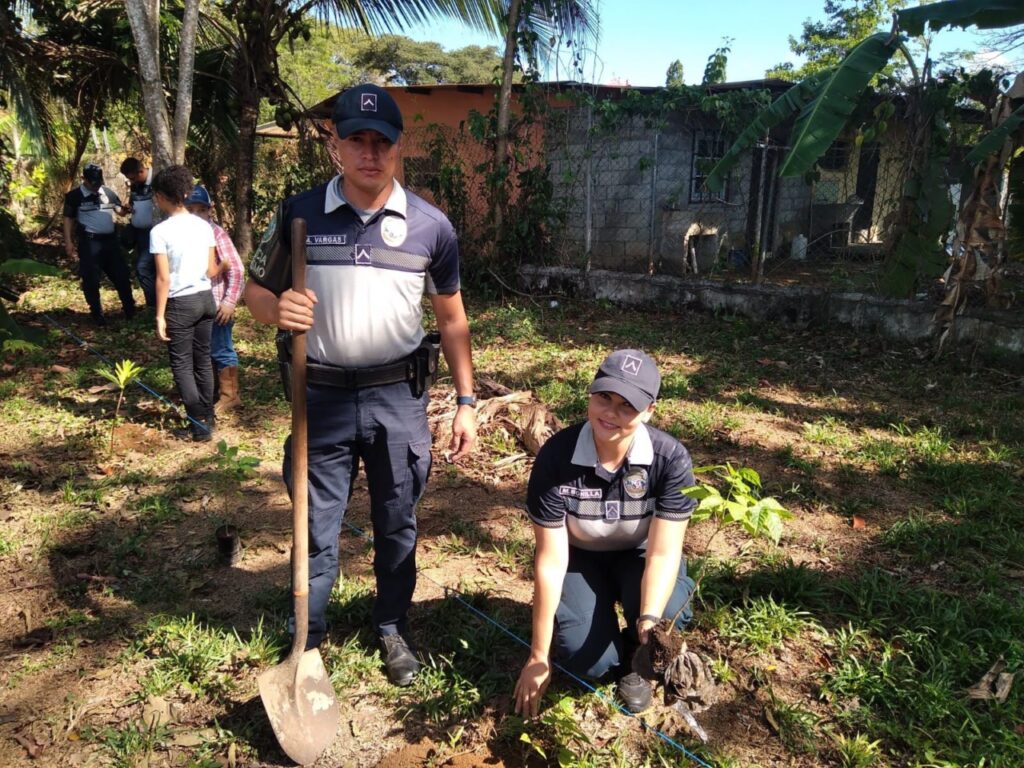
406, 0, 999, 85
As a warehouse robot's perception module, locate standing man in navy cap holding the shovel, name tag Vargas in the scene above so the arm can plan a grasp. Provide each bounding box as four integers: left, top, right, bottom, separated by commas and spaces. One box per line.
245, 85, 476, 686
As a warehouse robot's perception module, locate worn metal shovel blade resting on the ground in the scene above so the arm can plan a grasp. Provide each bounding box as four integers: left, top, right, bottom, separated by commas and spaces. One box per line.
258, 648, 338, 765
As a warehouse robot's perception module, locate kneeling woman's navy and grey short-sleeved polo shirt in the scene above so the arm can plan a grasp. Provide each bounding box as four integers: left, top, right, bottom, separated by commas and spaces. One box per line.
526, 422, 696, 552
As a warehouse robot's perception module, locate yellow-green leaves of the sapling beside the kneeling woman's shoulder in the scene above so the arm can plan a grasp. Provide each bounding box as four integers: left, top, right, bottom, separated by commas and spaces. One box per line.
682, 464, 793, 544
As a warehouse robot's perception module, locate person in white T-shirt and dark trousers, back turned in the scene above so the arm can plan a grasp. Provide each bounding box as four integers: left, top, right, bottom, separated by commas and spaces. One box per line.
150, 165, 219, 441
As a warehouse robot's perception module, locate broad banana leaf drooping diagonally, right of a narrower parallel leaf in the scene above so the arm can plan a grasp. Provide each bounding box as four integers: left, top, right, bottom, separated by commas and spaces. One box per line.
778, 32, 899, 176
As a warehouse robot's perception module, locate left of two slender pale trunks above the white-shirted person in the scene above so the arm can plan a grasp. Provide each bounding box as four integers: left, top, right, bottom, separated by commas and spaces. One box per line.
125, 0, 174, 170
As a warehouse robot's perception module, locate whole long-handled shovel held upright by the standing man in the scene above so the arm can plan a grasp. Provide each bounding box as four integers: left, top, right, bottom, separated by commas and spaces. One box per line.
258, 219, 338, 765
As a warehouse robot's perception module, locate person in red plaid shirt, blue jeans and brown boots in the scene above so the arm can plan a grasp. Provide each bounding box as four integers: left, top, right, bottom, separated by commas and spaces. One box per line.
186, 185, 245, 413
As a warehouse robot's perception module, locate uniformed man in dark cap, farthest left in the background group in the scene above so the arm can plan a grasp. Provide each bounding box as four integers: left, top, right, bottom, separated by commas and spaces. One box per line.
63, 163, 135, 326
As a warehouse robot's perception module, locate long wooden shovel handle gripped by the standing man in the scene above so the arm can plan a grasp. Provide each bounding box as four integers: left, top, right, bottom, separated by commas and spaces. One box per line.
291, 219, 309, 657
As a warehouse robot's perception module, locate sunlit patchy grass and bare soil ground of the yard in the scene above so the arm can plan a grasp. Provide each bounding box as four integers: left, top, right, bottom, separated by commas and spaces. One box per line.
0, 262, 1024, 768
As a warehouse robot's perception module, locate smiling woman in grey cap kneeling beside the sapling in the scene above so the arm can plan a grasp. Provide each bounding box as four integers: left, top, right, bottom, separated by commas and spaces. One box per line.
515, 349, 696, 717
